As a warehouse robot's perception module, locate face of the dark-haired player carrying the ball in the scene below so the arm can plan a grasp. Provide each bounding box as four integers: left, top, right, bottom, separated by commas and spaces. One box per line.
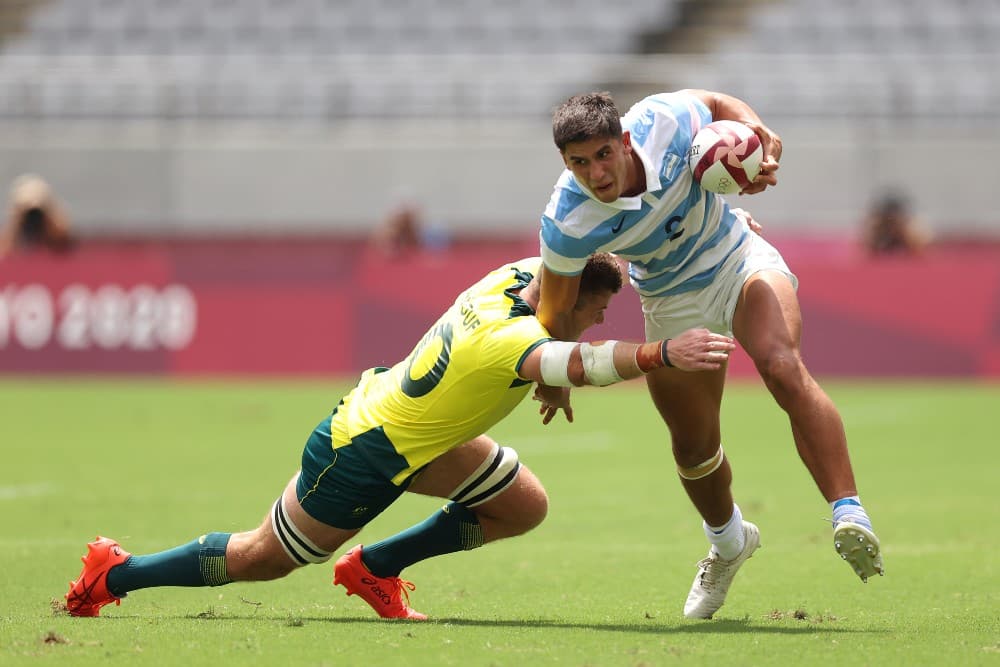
562, 133, 632, 203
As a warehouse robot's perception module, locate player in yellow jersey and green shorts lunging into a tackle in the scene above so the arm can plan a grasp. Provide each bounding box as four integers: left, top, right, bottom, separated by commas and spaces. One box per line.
66, 254, 734, 620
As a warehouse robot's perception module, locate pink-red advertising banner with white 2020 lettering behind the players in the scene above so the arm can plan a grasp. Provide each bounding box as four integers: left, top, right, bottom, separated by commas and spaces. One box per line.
0, 239, 1000, 377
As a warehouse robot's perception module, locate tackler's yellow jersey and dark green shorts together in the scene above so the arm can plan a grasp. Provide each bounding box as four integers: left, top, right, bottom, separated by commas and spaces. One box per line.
297, 258, 551, 528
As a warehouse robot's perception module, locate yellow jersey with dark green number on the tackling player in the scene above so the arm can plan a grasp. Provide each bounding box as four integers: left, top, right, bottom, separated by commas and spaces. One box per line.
330, 257, 552, 485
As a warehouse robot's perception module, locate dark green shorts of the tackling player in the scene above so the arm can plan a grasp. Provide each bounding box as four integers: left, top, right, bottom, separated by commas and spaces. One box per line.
295, 411, 413, 529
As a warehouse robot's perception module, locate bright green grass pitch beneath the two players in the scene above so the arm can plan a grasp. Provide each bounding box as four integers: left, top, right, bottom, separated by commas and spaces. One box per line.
0, 378, 1000, 667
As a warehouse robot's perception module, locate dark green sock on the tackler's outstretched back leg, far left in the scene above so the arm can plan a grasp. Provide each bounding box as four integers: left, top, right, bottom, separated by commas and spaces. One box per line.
108, 533, 231, 597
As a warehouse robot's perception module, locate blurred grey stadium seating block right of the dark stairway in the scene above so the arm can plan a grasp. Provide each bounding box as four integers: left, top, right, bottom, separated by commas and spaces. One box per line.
704, 0, 1000, 122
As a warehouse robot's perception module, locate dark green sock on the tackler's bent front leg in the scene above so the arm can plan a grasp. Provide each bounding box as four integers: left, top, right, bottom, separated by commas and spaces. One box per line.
361, 503, 483, 577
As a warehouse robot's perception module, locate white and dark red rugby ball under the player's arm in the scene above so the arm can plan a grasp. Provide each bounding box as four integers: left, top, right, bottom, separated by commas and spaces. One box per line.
688, 120, 764, 195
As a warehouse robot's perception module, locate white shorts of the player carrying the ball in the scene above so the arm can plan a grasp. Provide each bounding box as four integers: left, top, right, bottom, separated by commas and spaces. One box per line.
640, 233, 799, 340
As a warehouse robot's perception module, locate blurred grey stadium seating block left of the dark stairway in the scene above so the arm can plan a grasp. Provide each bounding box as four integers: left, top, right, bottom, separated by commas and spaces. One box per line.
0, 0, 676, 120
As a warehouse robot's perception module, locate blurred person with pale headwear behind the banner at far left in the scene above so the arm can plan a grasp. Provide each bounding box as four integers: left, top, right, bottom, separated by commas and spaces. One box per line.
0, 174, 74, 258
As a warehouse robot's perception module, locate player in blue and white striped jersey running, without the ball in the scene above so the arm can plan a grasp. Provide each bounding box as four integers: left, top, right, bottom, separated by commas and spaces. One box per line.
538, 90, 882, 618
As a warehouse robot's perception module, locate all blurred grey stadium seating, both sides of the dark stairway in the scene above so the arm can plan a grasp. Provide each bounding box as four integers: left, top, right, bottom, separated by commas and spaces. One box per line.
0, 0, 1000, 121
